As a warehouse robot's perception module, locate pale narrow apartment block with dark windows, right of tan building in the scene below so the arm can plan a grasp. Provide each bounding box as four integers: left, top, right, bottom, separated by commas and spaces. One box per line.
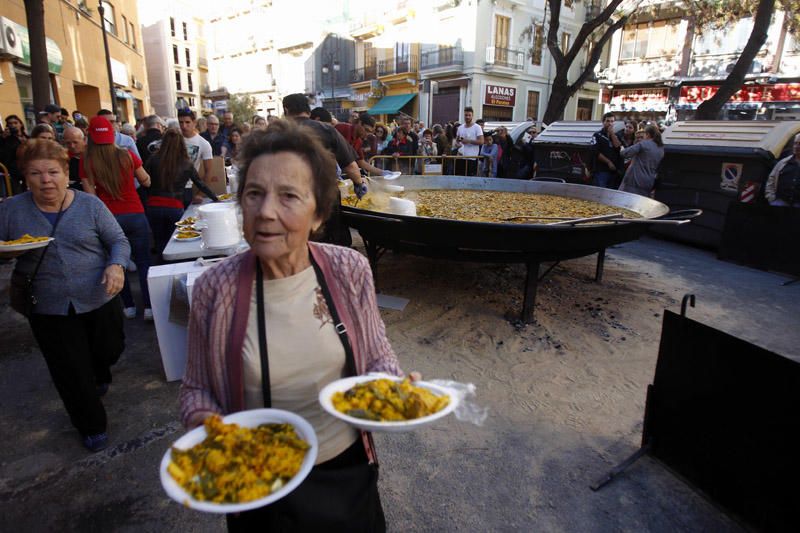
140, 0, 210, 117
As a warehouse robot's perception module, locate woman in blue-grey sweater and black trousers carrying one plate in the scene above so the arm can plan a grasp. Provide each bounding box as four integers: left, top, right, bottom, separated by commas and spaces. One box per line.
0, 140, 130, 451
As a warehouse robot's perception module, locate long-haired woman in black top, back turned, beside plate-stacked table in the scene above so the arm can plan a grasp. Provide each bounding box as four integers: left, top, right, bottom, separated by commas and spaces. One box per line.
145, 129, 218, 255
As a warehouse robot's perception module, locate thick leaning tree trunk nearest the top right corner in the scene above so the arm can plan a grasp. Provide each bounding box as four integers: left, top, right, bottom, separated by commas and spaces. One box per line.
694, 0, 775, 120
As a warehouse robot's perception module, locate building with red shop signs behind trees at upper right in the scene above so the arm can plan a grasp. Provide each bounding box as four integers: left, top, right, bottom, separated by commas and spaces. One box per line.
600, 2, 800, 122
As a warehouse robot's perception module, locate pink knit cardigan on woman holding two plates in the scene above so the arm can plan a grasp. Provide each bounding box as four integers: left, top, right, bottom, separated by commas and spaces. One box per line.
180, 243, 402, 461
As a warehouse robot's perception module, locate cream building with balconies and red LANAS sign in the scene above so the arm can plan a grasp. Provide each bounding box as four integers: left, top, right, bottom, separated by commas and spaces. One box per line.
350, 0, 599, 124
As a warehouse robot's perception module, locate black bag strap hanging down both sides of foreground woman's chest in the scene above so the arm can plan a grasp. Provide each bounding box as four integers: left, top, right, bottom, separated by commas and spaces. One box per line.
256, 254, 356, 407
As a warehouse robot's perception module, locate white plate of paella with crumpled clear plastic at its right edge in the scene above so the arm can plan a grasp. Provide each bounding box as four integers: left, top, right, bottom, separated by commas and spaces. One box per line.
319, 374, 458, 433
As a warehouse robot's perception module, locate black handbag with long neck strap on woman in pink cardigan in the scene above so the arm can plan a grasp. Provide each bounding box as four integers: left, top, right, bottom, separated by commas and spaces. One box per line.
228, 252, 386, 533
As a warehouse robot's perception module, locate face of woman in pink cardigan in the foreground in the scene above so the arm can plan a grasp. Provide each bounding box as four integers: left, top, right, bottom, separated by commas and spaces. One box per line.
241, 152, 322, 261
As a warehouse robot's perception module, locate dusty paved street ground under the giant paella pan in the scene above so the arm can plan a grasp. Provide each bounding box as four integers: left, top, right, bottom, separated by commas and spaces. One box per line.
0, 240, 800, 532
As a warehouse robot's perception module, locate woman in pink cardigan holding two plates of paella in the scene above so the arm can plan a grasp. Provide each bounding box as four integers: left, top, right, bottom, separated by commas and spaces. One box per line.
180, 121, 401, 531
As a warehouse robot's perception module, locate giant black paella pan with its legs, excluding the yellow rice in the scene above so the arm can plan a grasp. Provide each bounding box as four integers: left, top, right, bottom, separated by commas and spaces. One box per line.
342, 176, 699, 324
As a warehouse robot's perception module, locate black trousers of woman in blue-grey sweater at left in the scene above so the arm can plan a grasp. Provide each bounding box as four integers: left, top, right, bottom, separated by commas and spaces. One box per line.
28, 298, 125, 436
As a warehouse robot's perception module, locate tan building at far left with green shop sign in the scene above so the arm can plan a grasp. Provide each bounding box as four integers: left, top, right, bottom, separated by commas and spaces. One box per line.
0, 0, 151, 125
